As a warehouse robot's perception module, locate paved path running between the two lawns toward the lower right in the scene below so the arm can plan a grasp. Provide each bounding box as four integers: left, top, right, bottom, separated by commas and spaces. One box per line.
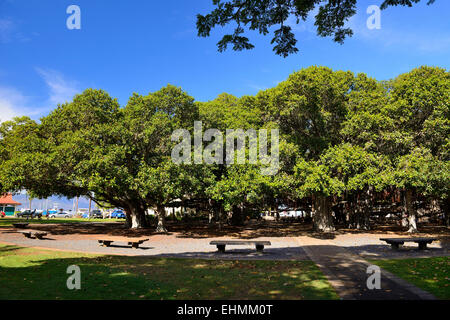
297, 237, 435, 300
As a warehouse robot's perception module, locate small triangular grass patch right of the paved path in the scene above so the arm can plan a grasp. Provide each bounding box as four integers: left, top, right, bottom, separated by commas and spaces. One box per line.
371, 257, 450, 300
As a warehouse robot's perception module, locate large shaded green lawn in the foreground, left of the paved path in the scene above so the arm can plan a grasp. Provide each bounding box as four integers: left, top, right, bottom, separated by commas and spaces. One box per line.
0, 245, 338, 300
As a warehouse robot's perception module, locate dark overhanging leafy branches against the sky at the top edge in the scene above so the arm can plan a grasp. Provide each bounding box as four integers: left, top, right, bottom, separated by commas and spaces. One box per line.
197, 0, 434, 57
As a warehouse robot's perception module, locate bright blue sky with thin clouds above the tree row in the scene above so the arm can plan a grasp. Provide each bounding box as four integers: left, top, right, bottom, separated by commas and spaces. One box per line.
0, 0, 450, 121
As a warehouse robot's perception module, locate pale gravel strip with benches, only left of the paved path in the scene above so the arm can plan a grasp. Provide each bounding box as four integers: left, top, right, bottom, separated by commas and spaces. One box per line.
0, 230, 308, 260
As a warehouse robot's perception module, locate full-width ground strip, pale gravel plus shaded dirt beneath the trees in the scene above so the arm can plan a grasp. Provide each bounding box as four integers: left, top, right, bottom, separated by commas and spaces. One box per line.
0, 223, 450, 260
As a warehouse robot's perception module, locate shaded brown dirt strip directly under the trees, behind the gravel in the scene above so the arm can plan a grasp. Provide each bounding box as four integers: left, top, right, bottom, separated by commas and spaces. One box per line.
0, 218, 450, 240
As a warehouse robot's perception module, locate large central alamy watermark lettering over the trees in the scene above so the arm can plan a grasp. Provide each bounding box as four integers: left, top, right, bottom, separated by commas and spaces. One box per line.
172, 121, 280, 175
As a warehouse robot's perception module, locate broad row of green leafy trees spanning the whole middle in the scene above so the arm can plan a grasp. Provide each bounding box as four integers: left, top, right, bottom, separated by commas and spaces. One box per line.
0, 67, 450, 232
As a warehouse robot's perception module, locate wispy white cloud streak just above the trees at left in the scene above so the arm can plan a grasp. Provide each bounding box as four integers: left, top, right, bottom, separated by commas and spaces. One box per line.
36, 68, 79, 106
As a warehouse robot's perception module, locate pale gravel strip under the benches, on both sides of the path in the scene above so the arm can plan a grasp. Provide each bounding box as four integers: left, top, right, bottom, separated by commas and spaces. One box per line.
0, 226, 449, 260
